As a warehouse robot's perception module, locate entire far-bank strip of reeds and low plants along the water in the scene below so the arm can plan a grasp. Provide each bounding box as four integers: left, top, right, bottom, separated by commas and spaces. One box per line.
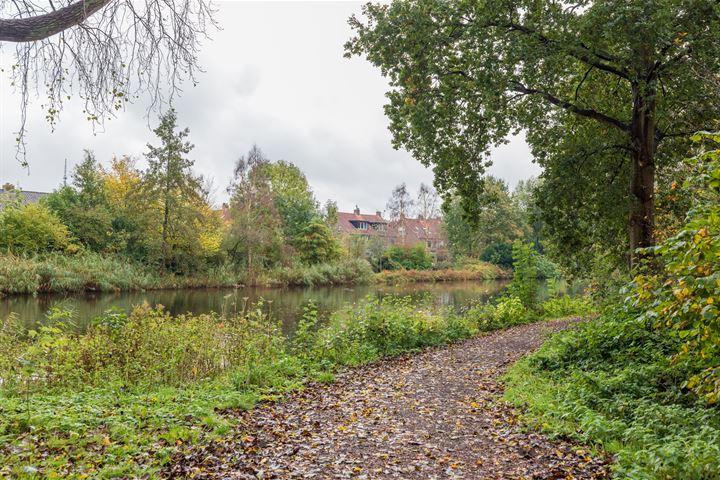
0, 253, 511, 297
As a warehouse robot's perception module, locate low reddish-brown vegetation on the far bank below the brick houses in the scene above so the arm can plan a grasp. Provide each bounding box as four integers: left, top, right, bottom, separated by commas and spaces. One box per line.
375, 262, 512, 285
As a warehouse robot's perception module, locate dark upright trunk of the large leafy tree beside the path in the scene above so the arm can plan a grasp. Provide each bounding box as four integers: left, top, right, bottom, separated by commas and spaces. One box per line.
630, 86, 656, 267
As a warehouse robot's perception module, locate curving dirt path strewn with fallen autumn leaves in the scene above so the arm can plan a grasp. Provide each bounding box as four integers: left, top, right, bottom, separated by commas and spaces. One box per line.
166, 321, 607, 479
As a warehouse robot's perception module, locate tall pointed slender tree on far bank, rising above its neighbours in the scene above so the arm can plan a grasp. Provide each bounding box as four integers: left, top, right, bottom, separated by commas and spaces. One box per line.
144, 108, 203, 267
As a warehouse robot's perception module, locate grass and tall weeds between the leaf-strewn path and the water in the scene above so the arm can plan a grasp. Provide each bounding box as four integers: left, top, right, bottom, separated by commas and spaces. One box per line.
0, 297, 592, 478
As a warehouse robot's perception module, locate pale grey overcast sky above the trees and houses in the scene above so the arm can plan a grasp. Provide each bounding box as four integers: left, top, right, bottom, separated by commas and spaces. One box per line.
0, 1, 539, 211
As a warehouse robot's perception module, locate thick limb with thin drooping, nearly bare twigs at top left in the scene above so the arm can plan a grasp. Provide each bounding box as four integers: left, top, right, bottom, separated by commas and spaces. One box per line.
0, 0, 215, 160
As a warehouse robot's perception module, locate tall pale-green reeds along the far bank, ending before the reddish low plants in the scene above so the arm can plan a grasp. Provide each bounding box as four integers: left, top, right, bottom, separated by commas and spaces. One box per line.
0, 253, 372, 295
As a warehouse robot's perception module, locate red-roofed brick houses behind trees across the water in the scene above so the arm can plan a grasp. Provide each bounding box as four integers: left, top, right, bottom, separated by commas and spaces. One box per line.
337, 207, 448, 258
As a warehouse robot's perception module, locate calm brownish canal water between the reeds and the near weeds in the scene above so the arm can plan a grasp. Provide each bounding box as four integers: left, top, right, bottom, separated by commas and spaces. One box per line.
0, 280, 507, 331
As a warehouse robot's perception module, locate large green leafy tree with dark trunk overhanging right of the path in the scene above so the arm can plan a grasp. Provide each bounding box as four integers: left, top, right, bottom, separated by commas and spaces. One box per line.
346, 0, 720, 266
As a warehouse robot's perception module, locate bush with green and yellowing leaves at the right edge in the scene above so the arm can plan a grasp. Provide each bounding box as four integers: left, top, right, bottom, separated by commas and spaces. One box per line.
633, 134, 720, 403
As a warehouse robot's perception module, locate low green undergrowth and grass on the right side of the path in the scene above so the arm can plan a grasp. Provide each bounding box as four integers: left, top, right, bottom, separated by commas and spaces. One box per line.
505, 309, 720, 480
